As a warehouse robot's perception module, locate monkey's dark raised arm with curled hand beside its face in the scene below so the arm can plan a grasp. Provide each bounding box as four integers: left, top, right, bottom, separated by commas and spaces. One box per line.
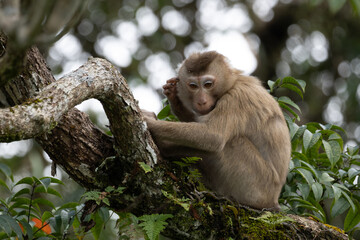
163, 78, 195, 122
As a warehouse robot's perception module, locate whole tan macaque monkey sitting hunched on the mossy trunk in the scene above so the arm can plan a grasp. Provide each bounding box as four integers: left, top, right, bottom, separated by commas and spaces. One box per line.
145, 51, 291, 210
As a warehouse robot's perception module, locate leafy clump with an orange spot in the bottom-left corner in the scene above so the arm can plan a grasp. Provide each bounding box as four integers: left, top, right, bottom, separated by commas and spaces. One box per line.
0, 168, 67, 239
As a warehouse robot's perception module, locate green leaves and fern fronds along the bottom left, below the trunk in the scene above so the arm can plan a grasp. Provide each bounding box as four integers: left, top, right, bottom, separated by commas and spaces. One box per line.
0, 166, 174, 240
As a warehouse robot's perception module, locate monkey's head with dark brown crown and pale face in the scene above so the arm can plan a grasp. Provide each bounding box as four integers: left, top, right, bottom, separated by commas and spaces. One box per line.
177, 51, 235, 115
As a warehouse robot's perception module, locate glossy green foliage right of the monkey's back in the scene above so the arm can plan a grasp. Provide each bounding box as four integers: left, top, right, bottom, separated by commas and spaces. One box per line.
268, 77, 360, 236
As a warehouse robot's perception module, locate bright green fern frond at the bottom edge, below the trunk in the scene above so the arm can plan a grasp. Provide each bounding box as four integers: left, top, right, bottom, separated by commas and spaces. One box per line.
139, 214, 173, 240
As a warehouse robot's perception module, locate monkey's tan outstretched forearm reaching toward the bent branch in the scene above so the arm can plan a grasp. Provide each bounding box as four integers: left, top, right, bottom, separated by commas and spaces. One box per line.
145, 117, 226, 152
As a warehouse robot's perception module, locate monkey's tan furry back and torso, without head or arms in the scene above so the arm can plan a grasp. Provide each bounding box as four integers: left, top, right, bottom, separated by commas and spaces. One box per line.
202, 76, 291, 208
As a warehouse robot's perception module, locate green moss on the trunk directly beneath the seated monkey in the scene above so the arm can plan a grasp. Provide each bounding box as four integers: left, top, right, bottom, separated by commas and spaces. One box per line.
156, 159, 300, 239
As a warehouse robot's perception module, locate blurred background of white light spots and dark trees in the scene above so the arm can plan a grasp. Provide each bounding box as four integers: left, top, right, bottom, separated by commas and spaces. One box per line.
0, 0, 360, 197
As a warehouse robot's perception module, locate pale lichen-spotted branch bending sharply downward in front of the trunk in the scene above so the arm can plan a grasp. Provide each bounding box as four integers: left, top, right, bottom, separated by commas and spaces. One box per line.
0, 58, 157, 166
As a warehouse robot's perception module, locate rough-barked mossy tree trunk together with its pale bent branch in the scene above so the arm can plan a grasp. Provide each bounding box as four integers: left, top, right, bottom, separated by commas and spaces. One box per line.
0, 35, 347, 239
